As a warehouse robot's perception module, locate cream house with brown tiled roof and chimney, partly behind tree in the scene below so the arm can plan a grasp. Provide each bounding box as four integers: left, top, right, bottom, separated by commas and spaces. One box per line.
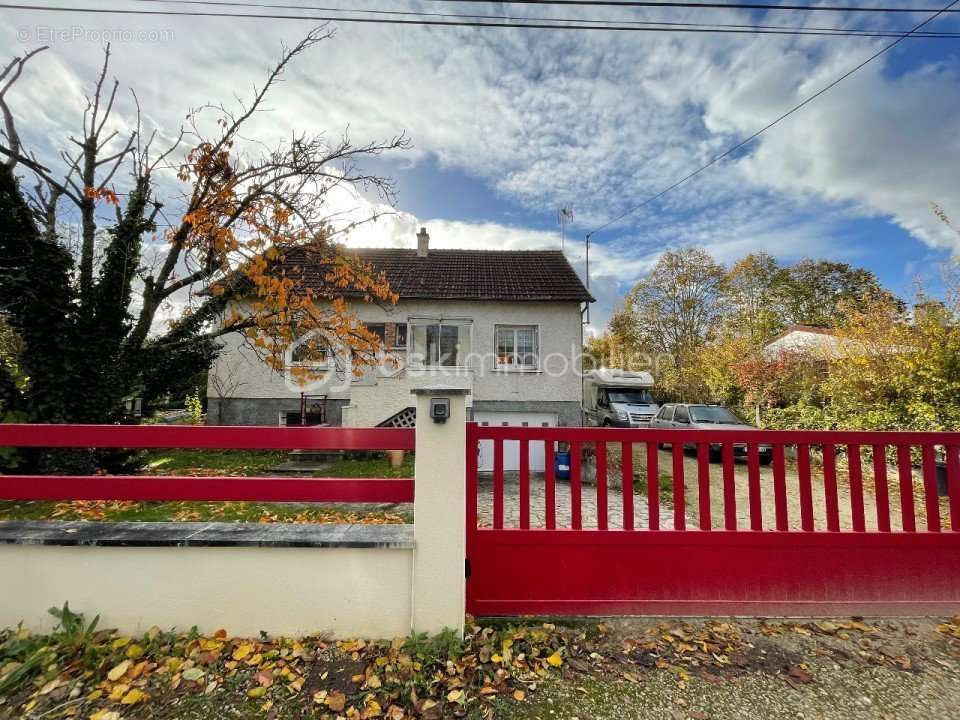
207, 229, 593, 450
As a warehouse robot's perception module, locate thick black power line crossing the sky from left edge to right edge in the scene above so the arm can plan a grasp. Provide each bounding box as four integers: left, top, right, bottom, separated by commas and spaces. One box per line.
0, 0, 957, 39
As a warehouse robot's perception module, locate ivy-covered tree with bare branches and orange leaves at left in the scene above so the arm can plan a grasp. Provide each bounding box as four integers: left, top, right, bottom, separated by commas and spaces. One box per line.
0, 28, 408, 448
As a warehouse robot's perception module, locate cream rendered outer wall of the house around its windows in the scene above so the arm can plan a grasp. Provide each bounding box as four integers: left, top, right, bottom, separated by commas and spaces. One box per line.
207, 300, 582, 425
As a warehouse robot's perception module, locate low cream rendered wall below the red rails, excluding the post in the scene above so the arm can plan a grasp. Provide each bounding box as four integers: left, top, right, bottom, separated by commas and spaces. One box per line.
0, 545, 413, 638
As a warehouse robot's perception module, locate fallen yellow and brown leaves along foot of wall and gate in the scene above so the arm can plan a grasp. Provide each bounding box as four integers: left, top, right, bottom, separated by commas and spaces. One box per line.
0, 615, 960, 720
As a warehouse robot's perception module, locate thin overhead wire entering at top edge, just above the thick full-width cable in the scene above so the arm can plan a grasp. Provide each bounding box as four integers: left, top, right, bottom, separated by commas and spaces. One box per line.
130, 0, 960, 38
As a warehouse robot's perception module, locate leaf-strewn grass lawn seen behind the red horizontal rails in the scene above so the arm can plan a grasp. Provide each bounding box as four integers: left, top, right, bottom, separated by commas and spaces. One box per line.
0, 449, 413, 525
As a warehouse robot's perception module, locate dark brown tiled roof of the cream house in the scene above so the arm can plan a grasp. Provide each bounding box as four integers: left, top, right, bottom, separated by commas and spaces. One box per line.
283, 248, 593, 302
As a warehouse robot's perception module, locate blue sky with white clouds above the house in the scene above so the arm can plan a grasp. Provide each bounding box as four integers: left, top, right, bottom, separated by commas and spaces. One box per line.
0, 0, 960, 325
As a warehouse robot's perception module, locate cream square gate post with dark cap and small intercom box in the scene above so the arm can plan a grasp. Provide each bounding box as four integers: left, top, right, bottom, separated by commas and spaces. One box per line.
411, 385, 470, 637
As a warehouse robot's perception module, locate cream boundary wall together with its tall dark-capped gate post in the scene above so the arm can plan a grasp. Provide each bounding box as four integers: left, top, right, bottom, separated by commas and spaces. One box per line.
0, 387, 469, 638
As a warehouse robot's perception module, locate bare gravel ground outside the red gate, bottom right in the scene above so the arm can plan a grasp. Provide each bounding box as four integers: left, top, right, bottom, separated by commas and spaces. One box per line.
497, 618, 960, 720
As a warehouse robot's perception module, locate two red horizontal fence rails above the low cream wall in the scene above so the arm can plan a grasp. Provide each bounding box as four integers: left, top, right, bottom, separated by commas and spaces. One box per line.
0, 424, 414, 503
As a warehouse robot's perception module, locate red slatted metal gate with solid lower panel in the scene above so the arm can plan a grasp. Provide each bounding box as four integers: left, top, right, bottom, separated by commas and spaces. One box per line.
466, 423, 960, 615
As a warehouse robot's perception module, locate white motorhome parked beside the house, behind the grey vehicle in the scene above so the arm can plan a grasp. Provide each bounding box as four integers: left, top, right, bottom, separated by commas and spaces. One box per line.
583, 369, 660, 427
